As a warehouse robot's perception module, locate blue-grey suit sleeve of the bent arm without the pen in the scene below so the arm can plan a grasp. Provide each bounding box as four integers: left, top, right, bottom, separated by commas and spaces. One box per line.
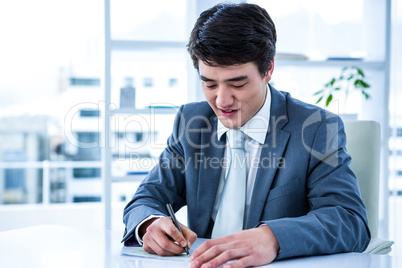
262, 117, 370, 259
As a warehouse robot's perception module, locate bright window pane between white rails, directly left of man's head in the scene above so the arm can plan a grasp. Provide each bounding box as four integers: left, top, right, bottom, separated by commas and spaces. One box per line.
111, 49, 189, 109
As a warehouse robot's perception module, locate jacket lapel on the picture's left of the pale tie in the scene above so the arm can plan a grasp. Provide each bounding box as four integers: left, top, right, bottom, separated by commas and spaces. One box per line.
197, 116, 226, 236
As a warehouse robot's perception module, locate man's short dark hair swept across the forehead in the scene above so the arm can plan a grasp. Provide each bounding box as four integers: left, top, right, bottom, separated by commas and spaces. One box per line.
187, 3, 276, 75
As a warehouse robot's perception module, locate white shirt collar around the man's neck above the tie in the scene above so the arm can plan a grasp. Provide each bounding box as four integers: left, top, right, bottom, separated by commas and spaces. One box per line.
217, 85, 271, 144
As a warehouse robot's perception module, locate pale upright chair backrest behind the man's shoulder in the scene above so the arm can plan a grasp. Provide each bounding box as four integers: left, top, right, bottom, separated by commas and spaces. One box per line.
344, 121, 381, 238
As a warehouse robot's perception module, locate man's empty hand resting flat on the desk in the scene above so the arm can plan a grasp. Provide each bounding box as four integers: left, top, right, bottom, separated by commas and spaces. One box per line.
190, 225, 279, 268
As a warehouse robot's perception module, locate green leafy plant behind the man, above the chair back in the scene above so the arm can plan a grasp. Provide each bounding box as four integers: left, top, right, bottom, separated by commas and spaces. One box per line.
314, 66, 370, 107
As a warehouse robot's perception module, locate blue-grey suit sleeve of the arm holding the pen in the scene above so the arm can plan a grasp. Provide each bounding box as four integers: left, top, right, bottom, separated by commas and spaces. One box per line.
123, 107, 186, 242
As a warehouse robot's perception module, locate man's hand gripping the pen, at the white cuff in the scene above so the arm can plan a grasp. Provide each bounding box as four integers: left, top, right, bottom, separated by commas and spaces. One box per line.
139, 217, 197, 256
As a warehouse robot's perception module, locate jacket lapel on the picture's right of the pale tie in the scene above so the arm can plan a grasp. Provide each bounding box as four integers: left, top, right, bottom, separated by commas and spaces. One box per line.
246, 87, 290, 228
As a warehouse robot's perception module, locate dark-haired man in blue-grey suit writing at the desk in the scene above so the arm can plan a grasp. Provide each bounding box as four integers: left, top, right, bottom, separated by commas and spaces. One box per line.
123, 3, 370, 267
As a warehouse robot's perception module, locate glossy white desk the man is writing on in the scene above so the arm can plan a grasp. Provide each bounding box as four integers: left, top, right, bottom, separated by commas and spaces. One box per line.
0, 226, 398, 268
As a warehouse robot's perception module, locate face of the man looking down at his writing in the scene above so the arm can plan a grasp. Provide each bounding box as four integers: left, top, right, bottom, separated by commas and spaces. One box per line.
198, 61, 274, 128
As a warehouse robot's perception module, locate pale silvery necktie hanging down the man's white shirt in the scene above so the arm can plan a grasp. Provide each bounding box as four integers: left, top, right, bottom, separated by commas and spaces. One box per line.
212, 129, 246, 238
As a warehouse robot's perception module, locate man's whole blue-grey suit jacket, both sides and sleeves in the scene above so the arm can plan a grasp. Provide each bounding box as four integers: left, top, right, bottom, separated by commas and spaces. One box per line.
123, 87, 370, 259
